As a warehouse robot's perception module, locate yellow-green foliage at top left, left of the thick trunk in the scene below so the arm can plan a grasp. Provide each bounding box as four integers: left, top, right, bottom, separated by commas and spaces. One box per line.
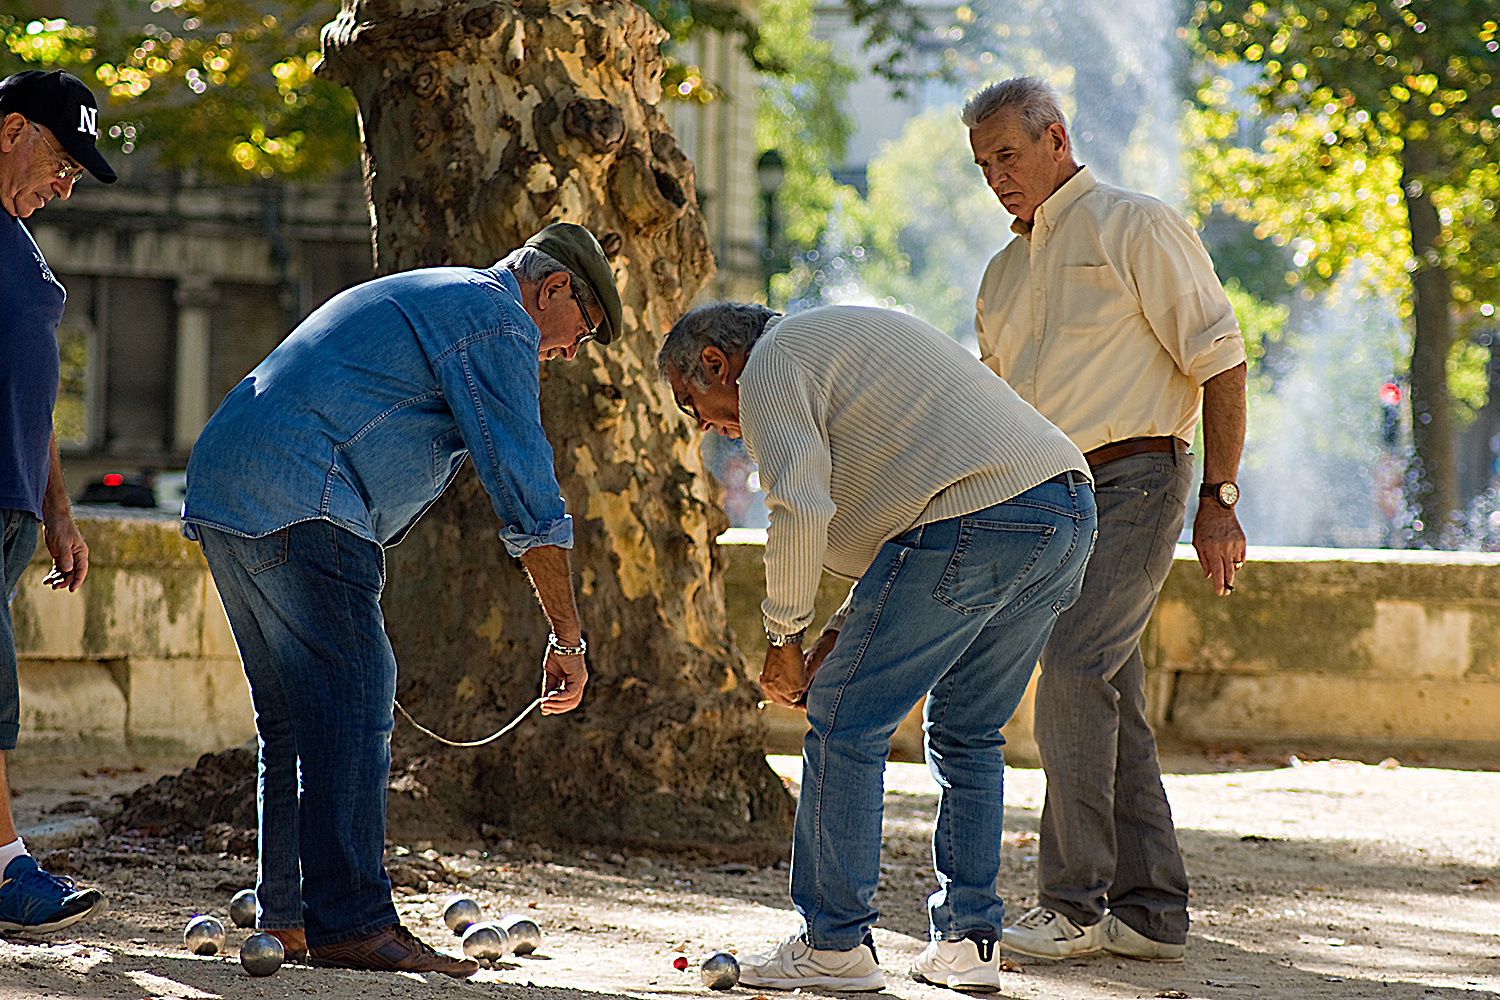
0, 0, 359, 181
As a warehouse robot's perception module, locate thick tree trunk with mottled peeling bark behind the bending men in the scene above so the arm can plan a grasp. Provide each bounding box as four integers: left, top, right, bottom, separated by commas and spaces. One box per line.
310, 0, 791, 856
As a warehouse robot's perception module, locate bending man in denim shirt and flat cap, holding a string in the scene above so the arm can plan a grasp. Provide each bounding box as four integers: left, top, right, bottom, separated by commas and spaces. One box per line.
183, 222, 621, 976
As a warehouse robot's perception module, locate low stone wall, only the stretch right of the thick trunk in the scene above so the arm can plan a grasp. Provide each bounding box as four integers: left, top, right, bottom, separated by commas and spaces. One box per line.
723, 531, 1500, 763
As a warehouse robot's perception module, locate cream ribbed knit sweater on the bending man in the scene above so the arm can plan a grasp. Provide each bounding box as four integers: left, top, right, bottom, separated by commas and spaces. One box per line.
740, 306, 1089, 634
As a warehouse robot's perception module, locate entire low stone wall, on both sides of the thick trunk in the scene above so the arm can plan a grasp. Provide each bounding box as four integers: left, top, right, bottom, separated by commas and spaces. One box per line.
12, 521, 1500, 763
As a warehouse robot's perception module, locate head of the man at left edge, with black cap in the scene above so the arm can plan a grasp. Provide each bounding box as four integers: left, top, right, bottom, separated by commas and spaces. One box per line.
0, 69, 116, 219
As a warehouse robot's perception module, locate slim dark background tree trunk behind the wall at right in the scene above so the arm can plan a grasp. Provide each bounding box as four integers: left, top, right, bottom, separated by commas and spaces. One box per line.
1401, 139, 1458, 547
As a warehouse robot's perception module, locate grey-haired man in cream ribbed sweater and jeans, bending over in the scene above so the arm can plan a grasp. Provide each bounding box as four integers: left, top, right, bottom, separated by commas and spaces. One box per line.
657, 303, 1095, 991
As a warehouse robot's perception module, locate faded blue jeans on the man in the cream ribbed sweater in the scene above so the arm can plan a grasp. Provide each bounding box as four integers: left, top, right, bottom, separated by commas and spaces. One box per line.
792, 481, 1094, 951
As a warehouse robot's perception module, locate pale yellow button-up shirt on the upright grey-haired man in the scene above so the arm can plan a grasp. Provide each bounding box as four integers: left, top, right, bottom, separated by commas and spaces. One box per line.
974, 166, 1245, 451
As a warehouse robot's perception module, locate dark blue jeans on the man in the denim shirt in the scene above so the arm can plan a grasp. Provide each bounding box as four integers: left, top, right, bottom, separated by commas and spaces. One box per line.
200, 520, 399, 946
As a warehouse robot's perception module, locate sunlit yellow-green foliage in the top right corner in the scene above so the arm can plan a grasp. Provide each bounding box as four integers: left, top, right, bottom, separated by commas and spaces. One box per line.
1187, 0, 1500, 316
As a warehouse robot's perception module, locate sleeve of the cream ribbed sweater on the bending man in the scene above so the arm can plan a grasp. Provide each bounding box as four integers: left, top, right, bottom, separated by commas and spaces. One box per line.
740, 343, 837, 634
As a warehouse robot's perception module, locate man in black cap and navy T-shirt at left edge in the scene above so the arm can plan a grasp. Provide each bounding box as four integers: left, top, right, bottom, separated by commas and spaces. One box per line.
0, 70, 114, 934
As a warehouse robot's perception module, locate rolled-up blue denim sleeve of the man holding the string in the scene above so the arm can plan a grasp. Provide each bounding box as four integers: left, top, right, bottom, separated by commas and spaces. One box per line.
435, 328, 573, 556
